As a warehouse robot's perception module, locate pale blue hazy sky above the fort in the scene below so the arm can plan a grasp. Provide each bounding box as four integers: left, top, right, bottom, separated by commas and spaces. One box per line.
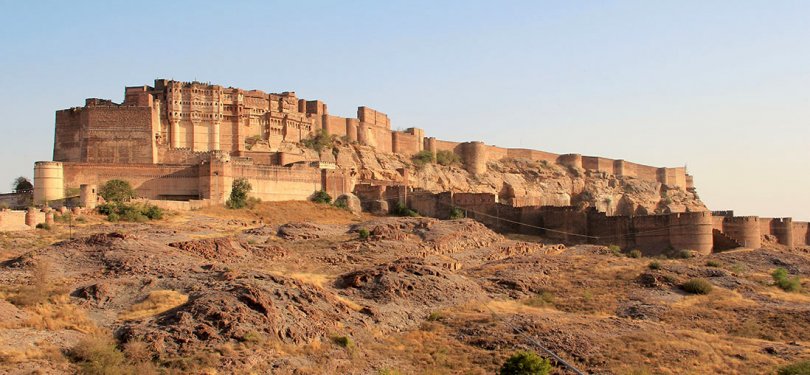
0, 0, 810, 220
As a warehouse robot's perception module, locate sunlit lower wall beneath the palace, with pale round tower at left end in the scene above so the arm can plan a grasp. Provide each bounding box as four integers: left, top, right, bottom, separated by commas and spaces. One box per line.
34, 153, 354, 207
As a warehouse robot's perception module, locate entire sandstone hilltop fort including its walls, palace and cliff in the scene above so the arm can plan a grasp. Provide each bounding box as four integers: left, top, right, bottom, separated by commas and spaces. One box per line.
11, 79, 808, 253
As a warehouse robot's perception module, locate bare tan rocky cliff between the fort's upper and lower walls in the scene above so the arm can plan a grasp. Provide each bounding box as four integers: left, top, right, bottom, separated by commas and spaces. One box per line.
321, 144, 706, 215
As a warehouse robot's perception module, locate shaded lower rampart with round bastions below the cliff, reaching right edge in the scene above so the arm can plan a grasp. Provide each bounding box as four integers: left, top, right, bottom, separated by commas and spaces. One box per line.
355, 187, 810, 255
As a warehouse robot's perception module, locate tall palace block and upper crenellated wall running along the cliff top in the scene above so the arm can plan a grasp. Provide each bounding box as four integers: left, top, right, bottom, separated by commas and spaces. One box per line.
53, 79, 693, 188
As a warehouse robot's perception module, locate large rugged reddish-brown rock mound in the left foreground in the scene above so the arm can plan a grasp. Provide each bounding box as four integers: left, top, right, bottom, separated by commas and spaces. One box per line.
121, 275, 362, 356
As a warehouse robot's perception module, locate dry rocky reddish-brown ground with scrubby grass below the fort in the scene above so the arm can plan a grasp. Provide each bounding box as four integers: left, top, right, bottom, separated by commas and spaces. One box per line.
0, 202, 810, 374
